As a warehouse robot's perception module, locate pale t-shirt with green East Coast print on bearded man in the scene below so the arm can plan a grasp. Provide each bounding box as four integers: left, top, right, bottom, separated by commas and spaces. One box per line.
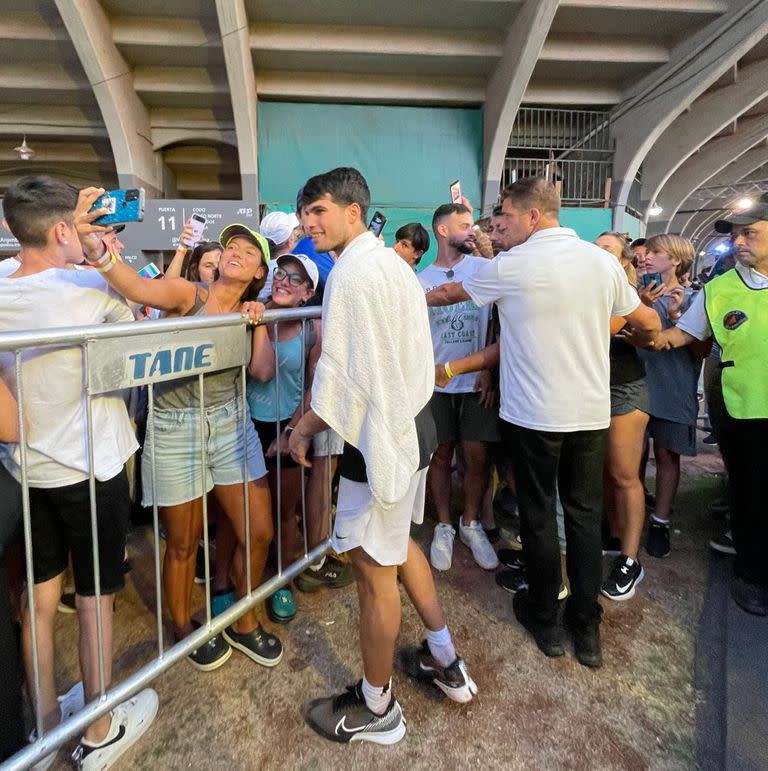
416, 254, 491, 394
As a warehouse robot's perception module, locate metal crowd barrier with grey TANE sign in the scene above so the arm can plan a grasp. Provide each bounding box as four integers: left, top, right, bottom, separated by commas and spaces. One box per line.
0, 307, 332, 771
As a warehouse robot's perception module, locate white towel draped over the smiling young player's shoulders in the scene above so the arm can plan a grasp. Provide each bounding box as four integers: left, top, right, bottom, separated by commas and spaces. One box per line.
312, 233, 435, 508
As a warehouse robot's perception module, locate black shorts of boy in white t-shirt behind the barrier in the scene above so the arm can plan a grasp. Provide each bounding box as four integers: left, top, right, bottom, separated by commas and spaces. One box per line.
29, 468, 131, 597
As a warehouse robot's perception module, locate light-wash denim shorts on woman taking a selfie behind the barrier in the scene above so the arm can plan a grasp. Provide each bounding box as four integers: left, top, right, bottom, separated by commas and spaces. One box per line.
141, 398, 267, 506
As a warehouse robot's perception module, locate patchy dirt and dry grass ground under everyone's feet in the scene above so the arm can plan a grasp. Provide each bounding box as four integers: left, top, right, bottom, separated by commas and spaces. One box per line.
43, 446, 720, 771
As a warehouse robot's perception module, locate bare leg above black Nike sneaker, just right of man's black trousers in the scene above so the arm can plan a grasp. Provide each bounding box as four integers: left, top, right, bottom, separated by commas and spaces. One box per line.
606, 410, 648, 560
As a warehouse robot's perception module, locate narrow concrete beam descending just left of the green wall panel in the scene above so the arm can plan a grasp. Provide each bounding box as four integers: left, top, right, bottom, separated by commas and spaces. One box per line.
216, 0, 259, 204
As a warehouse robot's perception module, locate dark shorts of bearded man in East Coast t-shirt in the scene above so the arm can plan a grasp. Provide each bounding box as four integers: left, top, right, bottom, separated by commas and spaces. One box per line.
429, 391, 501, 444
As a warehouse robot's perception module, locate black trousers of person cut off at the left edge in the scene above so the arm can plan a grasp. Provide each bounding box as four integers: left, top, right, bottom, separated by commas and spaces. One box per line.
0, 465, 25, 762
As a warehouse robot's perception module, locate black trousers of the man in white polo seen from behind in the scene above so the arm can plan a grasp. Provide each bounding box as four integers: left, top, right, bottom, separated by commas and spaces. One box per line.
503, 422, 608, 623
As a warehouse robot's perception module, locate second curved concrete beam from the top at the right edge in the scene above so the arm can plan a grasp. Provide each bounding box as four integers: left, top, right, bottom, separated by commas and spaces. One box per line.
641, 59, 768, 203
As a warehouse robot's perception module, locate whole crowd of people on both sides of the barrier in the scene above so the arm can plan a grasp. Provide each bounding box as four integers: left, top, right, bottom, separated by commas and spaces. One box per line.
0, 168, 768, 769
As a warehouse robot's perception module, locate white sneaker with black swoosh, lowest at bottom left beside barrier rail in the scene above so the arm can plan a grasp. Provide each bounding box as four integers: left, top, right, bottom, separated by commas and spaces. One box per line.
72, 688, 159, 771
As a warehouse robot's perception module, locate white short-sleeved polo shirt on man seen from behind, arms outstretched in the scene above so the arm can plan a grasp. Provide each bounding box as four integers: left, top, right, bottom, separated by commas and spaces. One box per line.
463, 227, 640, 431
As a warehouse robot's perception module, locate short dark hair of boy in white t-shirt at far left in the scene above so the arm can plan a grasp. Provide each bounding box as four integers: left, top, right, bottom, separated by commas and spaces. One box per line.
3, 174, 78, 248
